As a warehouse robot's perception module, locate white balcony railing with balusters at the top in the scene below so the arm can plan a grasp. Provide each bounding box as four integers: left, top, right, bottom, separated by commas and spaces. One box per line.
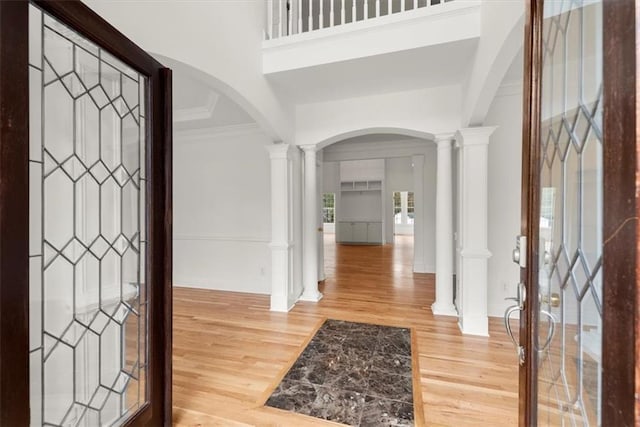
265, 0, 453, 40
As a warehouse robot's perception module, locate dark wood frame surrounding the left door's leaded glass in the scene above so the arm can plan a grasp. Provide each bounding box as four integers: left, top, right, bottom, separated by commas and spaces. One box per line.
0, 0, 172, 426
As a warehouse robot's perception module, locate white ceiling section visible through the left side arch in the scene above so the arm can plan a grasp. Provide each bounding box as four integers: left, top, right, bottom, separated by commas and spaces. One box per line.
173, 70, 255, 130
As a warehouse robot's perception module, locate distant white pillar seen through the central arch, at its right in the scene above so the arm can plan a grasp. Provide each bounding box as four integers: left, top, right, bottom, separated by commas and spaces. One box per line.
411, 154, 428, 273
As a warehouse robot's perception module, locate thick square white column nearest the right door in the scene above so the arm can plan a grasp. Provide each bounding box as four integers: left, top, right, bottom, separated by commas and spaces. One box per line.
456, 127, 495, 336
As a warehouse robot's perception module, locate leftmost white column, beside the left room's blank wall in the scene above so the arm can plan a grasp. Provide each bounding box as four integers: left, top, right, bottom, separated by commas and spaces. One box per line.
266, 144, 295, 312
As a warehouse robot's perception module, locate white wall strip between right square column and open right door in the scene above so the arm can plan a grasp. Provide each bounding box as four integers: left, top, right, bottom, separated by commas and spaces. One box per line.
485, 85, 522, 316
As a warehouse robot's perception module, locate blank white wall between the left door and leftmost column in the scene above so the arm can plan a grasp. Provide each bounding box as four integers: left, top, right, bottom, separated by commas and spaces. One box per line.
173, 127, 271, 294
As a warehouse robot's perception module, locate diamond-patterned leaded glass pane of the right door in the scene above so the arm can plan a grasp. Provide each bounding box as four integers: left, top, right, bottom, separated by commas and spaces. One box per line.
538, 0, 604, 426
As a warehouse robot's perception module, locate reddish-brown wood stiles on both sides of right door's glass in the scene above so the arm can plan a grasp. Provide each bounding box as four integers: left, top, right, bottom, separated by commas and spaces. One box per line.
519, 0, 640, 427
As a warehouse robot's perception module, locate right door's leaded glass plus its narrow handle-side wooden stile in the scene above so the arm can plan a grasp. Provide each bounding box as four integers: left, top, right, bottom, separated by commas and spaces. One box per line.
520, 0, 606, 426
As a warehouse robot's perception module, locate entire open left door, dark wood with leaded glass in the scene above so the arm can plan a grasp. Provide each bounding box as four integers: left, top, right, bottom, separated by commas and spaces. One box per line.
0, 0, 171, 426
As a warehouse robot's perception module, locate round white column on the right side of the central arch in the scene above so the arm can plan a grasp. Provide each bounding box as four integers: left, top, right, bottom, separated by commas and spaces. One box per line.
431, 135, 458, 316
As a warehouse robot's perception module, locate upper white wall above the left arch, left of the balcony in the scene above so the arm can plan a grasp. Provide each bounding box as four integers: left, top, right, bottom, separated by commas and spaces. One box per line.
83, 0, 294, 143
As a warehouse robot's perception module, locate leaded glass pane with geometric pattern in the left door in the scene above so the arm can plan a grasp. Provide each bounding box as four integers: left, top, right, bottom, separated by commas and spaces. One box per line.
29, 5, 148, 427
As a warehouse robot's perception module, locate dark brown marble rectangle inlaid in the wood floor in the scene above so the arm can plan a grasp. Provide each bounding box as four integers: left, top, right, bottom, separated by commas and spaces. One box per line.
265, 320, 414, 426
